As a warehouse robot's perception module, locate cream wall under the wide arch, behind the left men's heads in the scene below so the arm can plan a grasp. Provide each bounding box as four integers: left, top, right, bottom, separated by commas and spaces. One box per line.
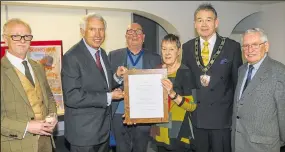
1, 5, 131, 53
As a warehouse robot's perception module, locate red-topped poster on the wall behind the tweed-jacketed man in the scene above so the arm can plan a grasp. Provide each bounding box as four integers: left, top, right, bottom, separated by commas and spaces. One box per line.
1, 40, 64, 115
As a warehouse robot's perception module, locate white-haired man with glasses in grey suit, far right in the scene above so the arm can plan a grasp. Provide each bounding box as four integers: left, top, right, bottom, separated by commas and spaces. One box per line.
232, 28, 285, 152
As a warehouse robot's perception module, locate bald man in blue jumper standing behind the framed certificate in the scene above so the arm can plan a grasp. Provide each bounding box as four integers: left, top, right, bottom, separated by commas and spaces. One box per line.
108, 23, 161, 152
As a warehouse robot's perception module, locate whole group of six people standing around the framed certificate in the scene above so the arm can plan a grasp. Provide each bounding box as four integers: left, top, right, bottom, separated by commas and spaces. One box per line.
1, 4, 285, 152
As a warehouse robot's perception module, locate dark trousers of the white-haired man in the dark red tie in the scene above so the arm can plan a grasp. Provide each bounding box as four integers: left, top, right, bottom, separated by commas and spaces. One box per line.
70, 139, 110, 152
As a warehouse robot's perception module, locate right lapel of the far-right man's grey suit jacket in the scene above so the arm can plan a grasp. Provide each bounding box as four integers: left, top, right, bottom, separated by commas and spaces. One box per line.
240, 56, 270, 100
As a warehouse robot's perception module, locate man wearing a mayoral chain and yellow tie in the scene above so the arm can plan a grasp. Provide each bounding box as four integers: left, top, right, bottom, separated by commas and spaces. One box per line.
182, 4, 242, 152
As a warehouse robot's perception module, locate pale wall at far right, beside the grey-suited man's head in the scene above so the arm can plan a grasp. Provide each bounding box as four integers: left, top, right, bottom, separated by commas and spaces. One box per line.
261, 2, 285, 64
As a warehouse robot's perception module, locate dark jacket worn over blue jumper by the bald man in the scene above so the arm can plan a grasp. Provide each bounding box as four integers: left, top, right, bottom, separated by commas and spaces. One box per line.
108, 48, 161, 115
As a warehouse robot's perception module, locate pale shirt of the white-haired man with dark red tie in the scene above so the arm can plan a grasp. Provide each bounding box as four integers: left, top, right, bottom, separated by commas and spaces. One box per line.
83, 38, 112, 106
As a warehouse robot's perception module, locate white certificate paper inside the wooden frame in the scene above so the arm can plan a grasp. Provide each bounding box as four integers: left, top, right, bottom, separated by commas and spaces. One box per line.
128, 74, 164, 119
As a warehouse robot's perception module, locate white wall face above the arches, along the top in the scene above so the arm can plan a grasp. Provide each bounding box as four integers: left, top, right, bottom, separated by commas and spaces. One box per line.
2, 1, 260, 42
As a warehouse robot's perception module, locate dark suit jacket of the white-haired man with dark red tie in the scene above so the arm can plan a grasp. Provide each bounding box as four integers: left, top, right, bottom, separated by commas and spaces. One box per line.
61, 40, 113, 146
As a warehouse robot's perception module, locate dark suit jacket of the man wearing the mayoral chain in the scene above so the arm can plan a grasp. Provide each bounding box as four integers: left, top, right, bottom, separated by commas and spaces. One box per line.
182, 34, 242, 129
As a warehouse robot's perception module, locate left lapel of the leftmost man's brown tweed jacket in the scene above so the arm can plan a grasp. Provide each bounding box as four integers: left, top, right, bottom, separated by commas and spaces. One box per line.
2, 56, 31, 106
